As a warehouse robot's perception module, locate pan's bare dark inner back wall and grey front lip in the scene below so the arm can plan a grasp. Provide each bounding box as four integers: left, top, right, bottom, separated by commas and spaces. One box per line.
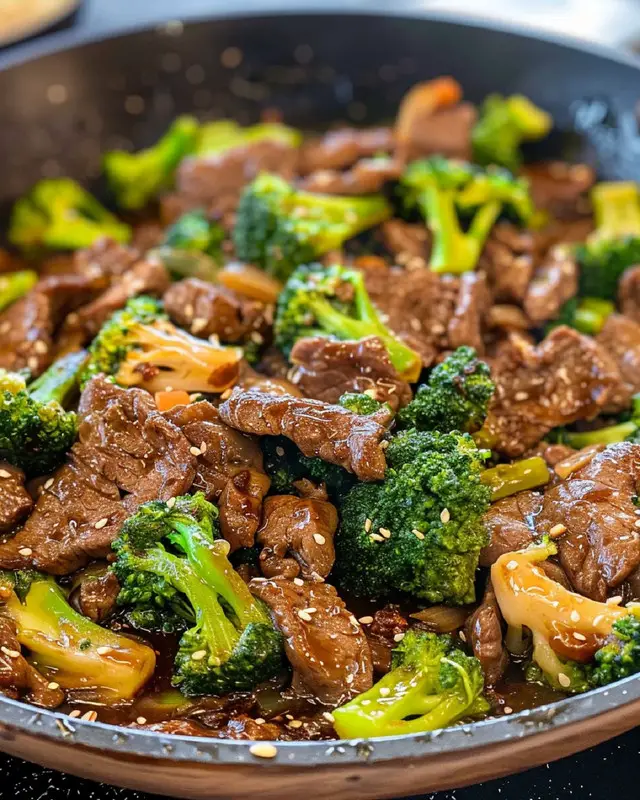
0, 4, 640, 766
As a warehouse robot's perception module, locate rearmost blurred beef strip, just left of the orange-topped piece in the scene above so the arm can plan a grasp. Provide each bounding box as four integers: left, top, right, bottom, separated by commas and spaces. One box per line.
299, 128, 393, 175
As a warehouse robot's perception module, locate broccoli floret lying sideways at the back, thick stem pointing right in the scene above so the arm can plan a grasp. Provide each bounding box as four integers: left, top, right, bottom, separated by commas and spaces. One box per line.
233, 174, 391, 281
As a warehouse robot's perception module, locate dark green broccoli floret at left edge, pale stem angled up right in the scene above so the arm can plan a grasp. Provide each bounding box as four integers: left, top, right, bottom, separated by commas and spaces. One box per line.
0, 352, 86, 476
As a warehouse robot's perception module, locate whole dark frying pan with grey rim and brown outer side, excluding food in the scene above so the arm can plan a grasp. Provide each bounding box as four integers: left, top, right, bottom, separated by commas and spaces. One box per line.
0, 7, 640, 800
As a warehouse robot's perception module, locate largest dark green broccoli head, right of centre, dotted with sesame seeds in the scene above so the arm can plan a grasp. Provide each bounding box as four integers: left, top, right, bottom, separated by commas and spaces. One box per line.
334, 429, 490, 605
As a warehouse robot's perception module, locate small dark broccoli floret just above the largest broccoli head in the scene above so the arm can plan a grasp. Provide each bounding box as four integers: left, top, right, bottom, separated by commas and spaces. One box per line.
398, 347, 495, 433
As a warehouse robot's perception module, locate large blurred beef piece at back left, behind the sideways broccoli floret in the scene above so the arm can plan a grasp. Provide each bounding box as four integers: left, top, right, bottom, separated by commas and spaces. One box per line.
162, 139, 298, 223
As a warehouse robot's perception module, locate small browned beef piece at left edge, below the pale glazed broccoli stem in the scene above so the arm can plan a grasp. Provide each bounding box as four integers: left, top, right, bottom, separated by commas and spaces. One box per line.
0, 613, 64, 708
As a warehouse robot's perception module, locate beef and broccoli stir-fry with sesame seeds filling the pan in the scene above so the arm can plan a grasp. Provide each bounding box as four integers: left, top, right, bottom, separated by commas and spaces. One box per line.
0, 78, 640, 740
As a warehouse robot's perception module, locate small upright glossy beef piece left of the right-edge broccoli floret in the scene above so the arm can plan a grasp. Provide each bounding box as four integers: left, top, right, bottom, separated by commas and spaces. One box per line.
523, 245, 578, 325
